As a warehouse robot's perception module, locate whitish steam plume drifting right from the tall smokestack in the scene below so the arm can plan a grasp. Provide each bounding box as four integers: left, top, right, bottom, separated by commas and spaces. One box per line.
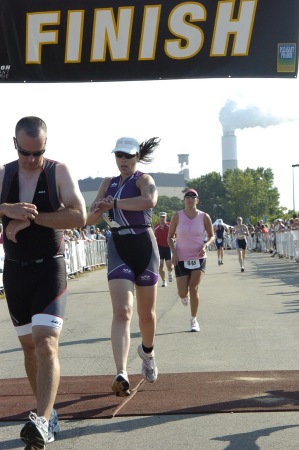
219, 99, 296, 134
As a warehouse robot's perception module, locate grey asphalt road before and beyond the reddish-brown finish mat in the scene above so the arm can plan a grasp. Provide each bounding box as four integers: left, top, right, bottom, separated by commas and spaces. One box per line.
0, 251, 299, 450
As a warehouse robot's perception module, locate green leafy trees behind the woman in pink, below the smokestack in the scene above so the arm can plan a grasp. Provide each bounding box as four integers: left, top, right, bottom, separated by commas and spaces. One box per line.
153, 167, 294, 225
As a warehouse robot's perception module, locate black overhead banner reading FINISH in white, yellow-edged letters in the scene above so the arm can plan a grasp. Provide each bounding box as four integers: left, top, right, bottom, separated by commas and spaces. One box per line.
0, 0, 299, 83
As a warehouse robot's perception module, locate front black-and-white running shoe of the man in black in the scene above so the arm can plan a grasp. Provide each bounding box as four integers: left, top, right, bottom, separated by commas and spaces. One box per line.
20, 412, 48, 450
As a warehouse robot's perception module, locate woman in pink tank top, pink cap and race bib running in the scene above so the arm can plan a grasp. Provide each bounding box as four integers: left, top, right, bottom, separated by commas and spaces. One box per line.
168, 189, 214, 331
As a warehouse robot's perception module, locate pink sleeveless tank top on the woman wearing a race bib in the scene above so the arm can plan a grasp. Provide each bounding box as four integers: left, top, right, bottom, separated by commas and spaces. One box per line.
176, 210, 206, 261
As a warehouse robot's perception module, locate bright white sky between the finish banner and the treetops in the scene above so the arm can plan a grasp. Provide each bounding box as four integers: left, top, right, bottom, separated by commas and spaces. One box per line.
0, 79, 299, 209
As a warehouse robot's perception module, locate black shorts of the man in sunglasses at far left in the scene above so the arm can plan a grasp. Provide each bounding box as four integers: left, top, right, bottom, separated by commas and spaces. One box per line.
3, 258, 67, 327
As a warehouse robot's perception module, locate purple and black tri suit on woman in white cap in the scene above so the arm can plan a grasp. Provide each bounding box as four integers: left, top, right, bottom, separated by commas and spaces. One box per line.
105, 171, 160, 286
